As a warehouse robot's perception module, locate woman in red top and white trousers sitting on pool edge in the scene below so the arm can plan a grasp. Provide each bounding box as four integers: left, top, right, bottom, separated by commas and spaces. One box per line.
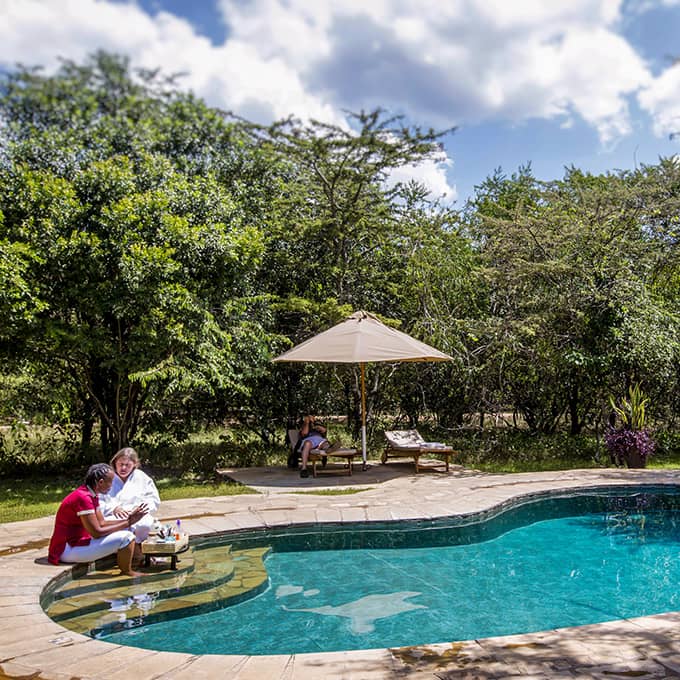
47, 463, 147, 576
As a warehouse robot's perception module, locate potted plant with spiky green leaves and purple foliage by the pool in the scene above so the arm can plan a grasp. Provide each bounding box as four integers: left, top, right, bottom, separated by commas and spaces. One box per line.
604, 385, 656, 468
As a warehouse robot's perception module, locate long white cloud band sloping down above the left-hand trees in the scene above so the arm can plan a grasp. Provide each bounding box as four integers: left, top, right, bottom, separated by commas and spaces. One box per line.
0, 0, 341, 122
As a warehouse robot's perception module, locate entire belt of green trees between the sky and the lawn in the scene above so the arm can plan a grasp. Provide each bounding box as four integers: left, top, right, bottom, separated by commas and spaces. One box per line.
0, 52, 680, 450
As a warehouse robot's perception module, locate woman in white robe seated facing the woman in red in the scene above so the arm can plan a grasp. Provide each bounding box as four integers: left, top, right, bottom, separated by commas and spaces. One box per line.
99, 447, 161, 554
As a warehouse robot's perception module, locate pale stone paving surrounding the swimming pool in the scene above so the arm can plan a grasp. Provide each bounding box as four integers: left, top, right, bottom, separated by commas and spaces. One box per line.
0, 464, 680, 680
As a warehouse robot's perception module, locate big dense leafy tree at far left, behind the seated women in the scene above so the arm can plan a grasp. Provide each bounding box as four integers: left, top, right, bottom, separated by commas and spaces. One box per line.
0, 53, 268, 450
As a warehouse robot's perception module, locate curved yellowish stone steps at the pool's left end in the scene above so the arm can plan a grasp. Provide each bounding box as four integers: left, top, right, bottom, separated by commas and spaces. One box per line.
47, 546, 270, 636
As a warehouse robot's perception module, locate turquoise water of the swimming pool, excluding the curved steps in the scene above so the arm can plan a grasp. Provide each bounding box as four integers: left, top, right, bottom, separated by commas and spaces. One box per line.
104, 486, 680, 654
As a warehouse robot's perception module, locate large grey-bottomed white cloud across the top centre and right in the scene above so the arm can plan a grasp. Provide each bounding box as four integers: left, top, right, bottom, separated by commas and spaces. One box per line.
220, 0, 650, 144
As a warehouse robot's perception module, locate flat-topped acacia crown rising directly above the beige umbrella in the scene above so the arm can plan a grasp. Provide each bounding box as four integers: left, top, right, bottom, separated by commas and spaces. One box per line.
253, 109, 448, 308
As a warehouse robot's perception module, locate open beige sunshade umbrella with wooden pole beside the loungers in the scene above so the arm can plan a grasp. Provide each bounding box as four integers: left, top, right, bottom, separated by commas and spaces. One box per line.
273, 311, 453, 466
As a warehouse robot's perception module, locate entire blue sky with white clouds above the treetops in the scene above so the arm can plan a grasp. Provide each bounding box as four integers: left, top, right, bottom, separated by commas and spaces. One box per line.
0, 0, 680, 207
